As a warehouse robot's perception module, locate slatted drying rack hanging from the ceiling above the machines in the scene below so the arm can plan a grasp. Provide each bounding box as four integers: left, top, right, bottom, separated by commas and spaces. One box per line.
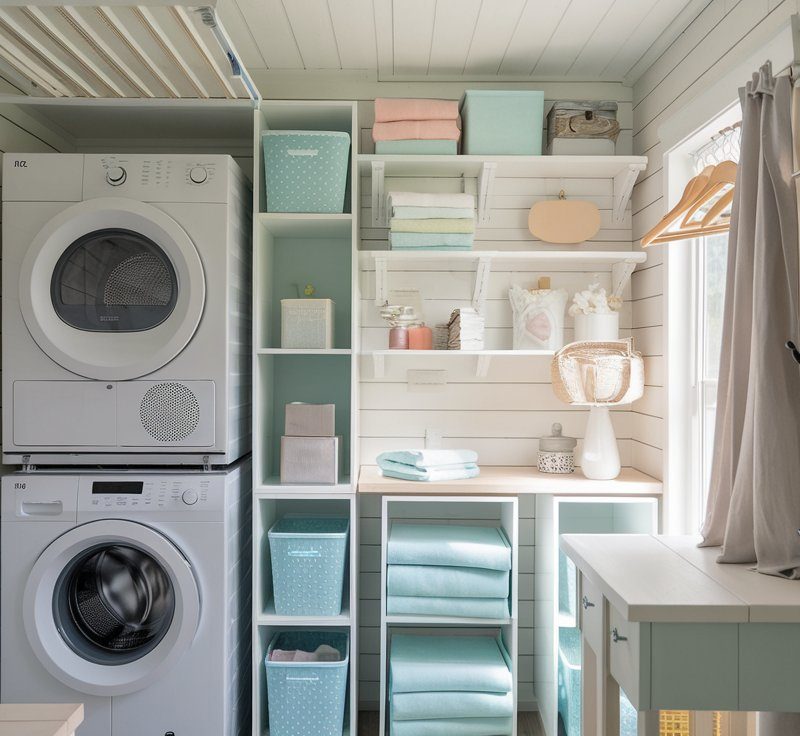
0, 0, 260, 100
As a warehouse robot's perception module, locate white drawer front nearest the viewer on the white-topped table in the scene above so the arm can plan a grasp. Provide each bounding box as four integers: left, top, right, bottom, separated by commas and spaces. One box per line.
606, 606, 650, 710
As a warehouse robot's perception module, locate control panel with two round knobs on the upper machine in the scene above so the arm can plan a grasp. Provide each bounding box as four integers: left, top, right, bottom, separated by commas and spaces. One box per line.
83, 154, 230, 203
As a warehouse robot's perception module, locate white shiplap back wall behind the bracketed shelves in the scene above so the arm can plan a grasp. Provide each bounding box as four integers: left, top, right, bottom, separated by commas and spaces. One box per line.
359, 85, 633, 709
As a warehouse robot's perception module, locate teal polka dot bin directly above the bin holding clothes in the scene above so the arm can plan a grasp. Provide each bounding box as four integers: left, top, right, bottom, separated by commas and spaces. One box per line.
268, 516, 350, 616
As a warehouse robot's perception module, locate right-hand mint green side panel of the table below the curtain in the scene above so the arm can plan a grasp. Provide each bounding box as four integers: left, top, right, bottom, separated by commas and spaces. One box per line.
739, 624, 800, 712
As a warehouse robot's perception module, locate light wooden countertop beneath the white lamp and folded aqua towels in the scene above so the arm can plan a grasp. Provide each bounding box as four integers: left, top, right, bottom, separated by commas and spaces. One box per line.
358, 465, 662, 496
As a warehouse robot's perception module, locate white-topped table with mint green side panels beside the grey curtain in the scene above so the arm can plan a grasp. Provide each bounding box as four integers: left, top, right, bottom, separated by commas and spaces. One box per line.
561, 534, 800, 736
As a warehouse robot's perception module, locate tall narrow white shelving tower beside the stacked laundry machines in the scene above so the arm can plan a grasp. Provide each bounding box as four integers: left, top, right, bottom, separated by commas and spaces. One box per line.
253, 101, 360, 736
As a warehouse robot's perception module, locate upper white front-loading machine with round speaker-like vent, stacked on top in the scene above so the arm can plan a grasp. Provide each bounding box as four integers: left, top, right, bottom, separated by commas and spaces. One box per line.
2, 154, 251, 465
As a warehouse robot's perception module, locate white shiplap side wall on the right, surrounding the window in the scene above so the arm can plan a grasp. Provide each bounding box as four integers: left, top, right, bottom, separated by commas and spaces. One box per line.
631, 0, 800, 486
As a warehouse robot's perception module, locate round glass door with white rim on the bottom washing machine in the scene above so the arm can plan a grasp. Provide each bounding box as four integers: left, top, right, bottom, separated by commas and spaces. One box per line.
22, 520, 200, 696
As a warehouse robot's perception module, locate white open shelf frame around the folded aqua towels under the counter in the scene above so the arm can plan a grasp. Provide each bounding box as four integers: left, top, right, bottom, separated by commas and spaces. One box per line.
379, 495, 519, 736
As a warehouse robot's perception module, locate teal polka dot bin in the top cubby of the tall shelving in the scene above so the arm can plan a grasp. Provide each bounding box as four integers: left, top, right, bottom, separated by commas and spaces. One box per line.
262, 130, 350, 213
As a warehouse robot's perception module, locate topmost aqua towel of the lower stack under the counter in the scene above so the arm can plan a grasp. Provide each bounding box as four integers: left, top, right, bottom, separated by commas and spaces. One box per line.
389, 634, 512, 693
